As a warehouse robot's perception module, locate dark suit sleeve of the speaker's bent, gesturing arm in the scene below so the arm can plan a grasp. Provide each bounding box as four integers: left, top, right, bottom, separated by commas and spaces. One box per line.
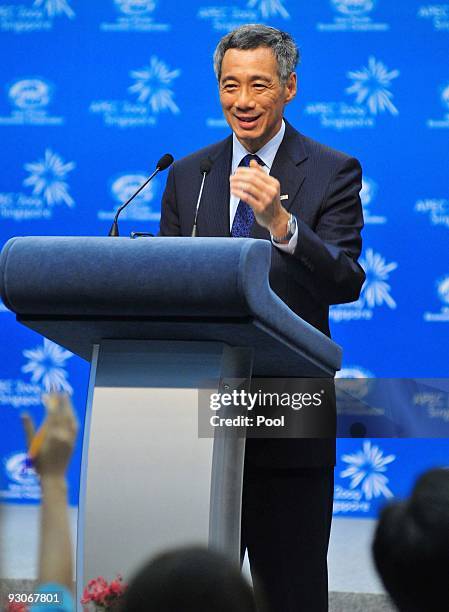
284, 158, 365, 304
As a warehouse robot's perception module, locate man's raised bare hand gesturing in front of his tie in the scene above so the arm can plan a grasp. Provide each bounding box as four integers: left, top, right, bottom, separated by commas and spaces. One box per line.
230, 159, 290, 236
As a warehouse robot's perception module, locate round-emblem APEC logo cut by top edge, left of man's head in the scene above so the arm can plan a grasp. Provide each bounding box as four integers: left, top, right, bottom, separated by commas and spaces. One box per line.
100, 0, 171, 32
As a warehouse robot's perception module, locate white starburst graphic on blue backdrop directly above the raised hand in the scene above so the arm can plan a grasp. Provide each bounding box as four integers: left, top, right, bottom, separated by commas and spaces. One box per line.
22, 338, 73, 393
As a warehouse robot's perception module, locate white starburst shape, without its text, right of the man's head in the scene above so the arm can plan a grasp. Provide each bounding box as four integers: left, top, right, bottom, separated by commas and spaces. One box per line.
346, 57, 400, 115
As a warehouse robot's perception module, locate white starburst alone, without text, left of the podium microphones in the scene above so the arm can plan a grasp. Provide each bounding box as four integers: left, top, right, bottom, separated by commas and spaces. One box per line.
23, 149, 75, 206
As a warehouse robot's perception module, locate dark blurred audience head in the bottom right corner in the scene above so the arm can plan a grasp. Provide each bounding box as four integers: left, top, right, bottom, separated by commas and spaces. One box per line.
373, 469, 449, 612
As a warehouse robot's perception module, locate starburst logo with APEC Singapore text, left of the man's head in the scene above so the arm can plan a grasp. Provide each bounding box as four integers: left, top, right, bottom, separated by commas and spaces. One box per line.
89, 55, 181, 129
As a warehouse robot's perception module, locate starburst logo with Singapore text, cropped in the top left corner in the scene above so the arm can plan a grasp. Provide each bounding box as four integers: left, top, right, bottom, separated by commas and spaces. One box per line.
0, 0, 75, 34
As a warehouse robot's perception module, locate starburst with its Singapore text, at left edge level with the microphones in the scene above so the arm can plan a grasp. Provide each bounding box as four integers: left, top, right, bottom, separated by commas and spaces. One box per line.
0, 148, 75, 221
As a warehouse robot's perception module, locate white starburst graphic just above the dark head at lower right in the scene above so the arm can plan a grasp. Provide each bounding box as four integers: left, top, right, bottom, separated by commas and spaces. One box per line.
340, 440, 396, 500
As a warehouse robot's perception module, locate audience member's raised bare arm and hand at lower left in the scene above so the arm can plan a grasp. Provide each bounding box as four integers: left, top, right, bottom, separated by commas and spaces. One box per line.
22, 393, 78, 612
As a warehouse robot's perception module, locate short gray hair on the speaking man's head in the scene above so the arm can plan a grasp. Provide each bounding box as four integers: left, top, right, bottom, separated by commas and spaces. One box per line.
214, 23, 299, 85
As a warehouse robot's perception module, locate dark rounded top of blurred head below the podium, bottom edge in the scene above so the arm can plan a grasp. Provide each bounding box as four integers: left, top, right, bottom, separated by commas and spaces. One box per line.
121, 548, 263, 612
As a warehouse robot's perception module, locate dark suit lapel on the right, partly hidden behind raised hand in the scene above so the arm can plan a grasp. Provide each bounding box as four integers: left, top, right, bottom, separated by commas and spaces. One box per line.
250, 119, 307, 238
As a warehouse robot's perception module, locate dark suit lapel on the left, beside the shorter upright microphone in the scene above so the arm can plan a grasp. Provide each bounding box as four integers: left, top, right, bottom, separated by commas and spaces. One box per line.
198, 136, 232, 236
